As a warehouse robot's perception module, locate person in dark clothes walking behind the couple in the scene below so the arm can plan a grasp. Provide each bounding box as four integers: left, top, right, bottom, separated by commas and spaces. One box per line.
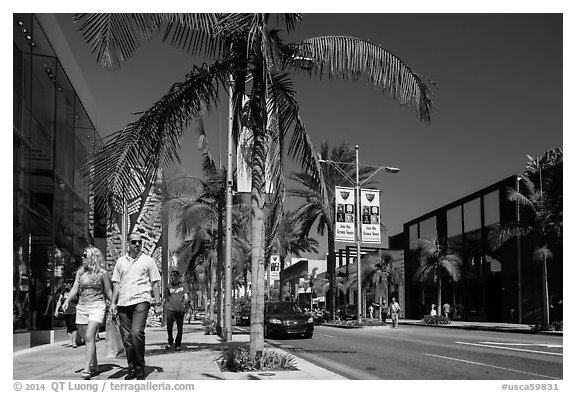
164, 270, 189, 351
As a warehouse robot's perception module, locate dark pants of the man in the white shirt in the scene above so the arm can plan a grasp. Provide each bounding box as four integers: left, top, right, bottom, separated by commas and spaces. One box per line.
118, 302, 150, 375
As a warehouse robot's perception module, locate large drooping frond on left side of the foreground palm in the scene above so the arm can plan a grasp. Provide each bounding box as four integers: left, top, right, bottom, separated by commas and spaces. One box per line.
82, 64, 226, 214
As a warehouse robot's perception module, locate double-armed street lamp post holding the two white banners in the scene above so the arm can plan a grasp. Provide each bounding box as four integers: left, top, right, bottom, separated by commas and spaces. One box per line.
318, 145, 400, 322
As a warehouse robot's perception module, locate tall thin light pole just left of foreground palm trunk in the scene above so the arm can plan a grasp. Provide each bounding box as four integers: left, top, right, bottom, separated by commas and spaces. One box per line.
223, 74, 234, 342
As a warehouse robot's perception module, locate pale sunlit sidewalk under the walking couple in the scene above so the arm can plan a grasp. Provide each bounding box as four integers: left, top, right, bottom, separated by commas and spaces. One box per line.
12, 322, 345, 381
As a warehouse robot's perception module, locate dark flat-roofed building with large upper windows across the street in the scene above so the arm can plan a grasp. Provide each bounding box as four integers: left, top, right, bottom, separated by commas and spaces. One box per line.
400, 176, 563, 324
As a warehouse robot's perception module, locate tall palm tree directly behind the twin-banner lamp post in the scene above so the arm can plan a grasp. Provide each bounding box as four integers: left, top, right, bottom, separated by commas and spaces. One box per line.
287, 142, 374, 318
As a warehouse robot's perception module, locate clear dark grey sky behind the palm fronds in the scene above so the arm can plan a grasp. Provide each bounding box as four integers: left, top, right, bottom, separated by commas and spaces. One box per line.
48, 13, 563, 251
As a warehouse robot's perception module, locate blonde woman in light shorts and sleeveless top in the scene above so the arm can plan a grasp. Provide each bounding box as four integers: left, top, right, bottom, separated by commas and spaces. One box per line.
62, 246, 112, 379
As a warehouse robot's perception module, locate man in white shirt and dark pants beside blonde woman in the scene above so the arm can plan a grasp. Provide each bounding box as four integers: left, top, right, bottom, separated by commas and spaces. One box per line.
110, 233, 162, 380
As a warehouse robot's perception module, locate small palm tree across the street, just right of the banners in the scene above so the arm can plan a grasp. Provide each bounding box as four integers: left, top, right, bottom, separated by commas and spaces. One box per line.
362, 250, 402, 320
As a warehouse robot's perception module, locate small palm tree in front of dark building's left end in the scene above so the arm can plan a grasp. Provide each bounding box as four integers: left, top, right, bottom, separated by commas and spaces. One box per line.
416, 239, 462, 310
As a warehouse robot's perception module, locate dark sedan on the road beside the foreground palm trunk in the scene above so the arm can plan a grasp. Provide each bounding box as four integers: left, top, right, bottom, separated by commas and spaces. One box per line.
264, 302, 314, 338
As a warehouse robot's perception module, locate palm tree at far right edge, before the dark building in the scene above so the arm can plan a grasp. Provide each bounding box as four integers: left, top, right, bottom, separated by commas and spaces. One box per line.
490, 156, 563, 325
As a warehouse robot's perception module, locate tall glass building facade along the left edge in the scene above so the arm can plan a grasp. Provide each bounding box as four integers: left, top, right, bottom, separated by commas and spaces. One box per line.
13, 14, 106, 350
